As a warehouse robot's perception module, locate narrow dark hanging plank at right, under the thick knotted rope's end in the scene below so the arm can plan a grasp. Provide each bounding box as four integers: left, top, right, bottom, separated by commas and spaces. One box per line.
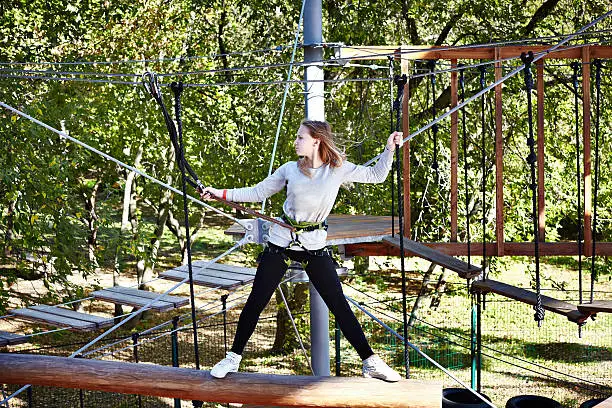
472, 279, 593, 323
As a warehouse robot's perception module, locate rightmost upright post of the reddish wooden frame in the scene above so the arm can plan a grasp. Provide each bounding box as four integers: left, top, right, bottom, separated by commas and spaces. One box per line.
582, 46, 593, 256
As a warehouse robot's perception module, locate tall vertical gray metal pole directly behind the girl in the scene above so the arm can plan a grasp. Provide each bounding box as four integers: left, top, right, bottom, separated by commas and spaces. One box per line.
304, 0, 330, 376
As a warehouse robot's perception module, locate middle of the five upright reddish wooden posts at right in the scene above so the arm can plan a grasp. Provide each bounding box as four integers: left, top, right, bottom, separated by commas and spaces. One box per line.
495, 48, 504, 256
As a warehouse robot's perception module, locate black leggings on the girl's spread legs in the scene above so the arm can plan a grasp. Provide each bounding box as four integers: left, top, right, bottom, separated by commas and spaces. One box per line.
232, 245, 374, 360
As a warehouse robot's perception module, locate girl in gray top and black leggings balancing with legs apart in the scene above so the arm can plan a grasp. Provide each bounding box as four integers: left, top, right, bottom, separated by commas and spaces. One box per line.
201, 120, 402, 381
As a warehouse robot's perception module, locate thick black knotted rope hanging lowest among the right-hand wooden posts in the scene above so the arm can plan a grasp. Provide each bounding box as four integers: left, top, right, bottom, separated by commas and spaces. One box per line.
521, 51, 544, 327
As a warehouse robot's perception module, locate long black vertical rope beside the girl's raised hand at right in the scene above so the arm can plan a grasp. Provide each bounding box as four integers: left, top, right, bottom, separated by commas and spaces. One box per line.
393, 74, 410, 378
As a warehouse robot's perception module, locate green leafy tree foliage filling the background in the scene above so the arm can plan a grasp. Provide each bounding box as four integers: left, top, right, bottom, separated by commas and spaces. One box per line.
0, 0, 612, 312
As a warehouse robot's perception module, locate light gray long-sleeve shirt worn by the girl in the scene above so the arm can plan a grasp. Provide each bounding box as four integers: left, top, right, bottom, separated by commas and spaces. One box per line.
227, 148, 393, 250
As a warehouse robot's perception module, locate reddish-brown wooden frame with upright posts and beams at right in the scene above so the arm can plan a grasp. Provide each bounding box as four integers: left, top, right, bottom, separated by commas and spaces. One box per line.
340, 45, 612, 256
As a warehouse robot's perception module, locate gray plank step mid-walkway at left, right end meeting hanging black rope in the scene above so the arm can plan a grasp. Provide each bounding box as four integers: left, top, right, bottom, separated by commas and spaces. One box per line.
92, 286, 189, 312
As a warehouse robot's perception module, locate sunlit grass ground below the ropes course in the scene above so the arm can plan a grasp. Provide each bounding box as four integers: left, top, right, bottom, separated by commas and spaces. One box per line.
0, 217, 612, 407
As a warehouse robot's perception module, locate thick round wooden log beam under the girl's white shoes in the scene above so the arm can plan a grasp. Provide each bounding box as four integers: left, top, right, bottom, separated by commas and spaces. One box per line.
0, 353, 442, 408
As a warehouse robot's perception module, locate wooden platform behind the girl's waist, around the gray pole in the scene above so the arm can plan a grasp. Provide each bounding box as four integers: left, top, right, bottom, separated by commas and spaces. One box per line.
225, 214, 399, 245
